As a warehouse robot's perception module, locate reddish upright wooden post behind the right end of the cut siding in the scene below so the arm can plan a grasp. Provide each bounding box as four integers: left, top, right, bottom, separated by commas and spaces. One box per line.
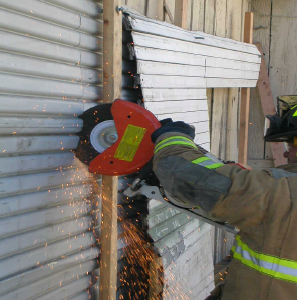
238, 12, 254, 165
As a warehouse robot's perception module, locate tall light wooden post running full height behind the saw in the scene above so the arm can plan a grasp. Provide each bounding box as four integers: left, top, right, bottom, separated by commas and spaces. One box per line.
99, 0, 122, 300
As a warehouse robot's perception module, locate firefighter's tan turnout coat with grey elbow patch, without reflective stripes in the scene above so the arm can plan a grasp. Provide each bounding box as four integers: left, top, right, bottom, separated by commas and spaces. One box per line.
154, 133, 297, 300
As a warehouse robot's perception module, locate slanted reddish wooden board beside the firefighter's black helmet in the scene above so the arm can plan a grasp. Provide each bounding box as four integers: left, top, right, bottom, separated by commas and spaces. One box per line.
256, 44, 288, 167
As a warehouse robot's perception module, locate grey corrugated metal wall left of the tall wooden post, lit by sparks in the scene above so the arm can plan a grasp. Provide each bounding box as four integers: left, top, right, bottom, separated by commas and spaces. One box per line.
0, 0, 102, 300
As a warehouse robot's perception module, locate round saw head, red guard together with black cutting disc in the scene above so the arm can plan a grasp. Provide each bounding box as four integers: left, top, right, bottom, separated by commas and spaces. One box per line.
76, 99, 161, 176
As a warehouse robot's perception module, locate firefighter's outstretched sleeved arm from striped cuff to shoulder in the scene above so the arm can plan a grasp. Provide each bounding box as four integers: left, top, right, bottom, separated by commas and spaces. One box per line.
154, 125, 277, 229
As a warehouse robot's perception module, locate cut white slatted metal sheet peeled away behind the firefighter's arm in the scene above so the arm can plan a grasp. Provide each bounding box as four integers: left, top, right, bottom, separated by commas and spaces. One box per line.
123, 12, 261, 300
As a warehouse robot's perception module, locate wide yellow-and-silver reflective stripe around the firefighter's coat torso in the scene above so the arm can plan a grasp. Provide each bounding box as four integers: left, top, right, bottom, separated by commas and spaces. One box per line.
232, 236, 297, 283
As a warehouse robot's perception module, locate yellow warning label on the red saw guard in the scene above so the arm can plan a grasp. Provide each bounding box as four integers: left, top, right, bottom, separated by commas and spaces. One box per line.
114, 125, 146, 162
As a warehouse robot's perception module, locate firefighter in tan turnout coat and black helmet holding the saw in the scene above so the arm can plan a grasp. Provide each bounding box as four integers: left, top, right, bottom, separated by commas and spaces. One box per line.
152, 96, 297, 300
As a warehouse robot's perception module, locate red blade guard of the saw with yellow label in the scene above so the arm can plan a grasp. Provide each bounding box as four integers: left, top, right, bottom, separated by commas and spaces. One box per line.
89, 100, 161, 176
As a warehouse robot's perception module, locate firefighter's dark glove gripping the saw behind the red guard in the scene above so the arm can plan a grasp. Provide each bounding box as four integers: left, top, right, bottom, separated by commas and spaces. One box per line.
152, 119, 195, 144
